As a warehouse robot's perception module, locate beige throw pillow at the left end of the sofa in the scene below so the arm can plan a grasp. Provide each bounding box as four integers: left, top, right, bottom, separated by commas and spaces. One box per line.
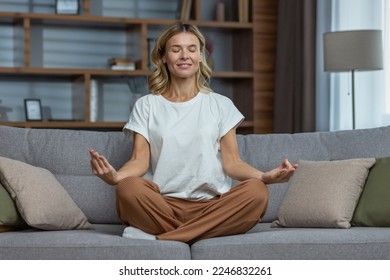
0, 157, 92, 230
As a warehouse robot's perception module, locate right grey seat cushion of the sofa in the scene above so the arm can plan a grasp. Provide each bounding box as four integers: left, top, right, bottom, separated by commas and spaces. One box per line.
191, 223, 390, 260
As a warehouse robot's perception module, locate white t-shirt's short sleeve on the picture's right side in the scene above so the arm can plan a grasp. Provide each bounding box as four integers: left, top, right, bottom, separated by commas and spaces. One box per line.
218, 96, 244, 138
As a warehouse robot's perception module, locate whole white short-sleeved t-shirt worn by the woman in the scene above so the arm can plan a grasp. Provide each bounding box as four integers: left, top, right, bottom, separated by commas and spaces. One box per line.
123, 92, 244, 200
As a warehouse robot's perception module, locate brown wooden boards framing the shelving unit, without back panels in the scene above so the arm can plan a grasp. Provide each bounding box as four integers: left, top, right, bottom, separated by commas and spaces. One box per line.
0, 0, 262, 133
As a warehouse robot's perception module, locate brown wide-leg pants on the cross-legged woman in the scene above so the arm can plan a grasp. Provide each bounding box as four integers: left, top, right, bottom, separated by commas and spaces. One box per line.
116, 177, 268, 243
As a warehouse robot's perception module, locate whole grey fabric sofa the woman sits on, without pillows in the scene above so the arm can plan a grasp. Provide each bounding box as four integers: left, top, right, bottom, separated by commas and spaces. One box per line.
0, 126, 390, 260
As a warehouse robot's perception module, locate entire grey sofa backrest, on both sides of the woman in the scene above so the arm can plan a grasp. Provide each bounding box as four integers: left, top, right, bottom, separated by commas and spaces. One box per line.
0, 126, 390, 223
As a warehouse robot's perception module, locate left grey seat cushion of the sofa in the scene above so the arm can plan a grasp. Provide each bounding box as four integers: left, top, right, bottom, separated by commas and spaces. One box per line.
0, 224, 191, 260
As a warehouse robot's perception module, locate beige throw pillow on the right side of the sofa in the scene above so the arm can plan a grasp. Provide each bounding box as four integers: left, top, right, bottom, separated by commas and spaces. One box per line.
271, 158, 375, 228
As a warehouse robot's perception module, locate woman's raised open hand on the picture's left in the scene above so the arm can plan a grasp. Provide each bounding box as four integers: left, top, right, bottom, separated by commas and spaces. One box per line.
89, 150, 119, 185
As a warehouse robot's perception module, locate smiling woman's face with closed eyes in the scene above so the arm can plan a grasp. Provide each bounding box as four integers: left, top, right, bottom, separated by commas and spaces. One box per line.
163, 32, 201, 79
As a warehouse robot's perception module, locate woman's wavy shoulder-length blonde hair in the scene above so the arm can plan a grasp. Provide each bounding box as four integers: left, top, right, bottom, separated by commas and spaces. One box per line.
148, 22, 212, 95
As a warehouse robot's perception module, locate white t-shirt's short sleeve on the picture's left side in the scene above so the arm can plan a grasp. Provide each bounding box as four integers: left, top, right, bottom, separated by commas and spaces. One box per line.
123, 96, 150, 142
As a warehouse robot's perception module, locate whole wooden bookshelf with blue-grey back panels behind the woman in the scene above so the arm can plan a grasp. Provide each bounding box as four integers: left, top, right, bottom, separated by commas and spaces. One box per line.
0, 0, 264, 133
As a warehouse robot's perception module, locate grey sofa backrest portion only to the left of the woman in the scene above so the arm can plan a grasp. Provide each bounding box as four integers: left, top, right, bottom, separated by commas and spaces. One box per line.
0, 126, 132, 223
